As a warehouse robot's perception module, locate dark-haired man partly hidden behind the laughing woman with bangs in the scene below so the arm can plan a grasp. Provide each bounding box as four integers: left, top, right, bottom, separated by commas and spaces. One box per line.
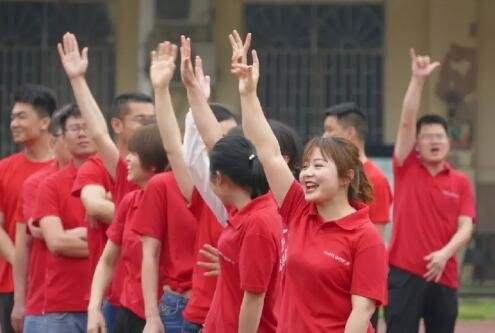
323, 103, 392, 329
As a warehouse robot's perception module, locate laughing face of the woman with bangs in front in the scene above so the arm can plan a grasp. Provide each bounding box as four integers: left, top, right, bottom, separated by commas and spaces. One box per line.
299, 147, 346, 204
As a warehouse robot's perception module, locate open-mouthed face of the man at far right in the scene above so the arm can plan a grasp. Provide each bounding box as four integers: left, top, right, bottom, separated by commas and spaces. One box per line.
416, 124, 450, 164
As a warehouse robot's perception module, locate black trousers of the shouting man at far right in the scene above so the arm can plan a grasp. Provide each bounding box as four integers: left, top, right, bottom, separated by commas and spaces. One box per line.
386, 267, 458, 333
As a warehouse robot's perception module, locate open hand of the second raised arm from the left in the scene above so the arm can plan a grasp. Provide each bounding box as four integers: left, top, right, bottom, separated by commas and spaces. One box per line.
150, 41, 177, 89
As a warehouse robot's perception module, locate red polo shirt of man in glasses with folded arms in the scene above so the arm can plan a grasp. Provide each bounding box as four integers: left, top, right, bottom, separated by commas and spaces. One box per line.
35, 162, 92, 312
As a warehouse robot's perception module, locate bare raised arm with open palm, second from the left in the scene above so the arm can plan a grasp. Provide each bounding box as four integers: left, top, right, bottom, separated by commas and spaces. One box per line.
150, 42, 193, 202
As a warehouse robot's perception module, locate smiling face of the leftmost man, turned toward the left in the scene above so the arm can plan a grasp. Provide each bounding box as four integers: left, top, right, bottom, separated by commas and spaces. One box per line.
10, 102, 50, 144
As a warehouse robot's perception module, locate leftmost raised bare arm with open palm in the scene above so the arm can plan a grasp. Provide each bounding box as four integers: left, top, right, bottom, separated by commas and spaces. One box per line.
57, 33, 119, 179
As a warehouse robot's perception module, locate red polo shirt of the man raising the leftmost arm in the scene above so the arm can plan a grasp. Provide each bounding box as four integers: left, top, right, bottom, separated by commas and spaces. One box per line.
72, 156, 138, 306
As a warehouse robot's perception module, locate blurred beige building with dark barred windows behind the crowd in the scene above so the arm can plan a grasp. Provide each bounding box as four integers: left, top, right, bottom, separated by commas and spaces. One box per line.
0, 0, 495, 293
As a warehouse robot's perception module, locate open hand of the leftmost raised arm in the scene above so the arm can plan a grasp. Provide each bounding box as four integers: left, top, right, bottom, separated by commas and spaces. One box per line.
57, 32, 88, 80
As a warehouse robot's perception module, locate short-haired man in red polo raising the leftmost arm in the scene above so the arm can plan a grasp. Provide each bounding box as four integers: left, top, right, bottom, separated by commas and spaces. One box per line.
58, 33, 154, 329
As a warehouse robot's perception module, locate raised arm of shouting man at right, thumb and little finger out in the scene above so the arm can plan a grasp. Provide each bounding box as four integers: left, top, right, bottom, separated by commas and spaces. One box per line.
394, 49, 440, 164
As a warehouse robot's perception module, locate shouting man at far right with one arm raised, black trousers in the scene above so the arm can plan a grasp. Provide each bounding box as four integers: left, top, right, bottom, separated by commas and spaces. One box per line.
387, 49, 475, 333
